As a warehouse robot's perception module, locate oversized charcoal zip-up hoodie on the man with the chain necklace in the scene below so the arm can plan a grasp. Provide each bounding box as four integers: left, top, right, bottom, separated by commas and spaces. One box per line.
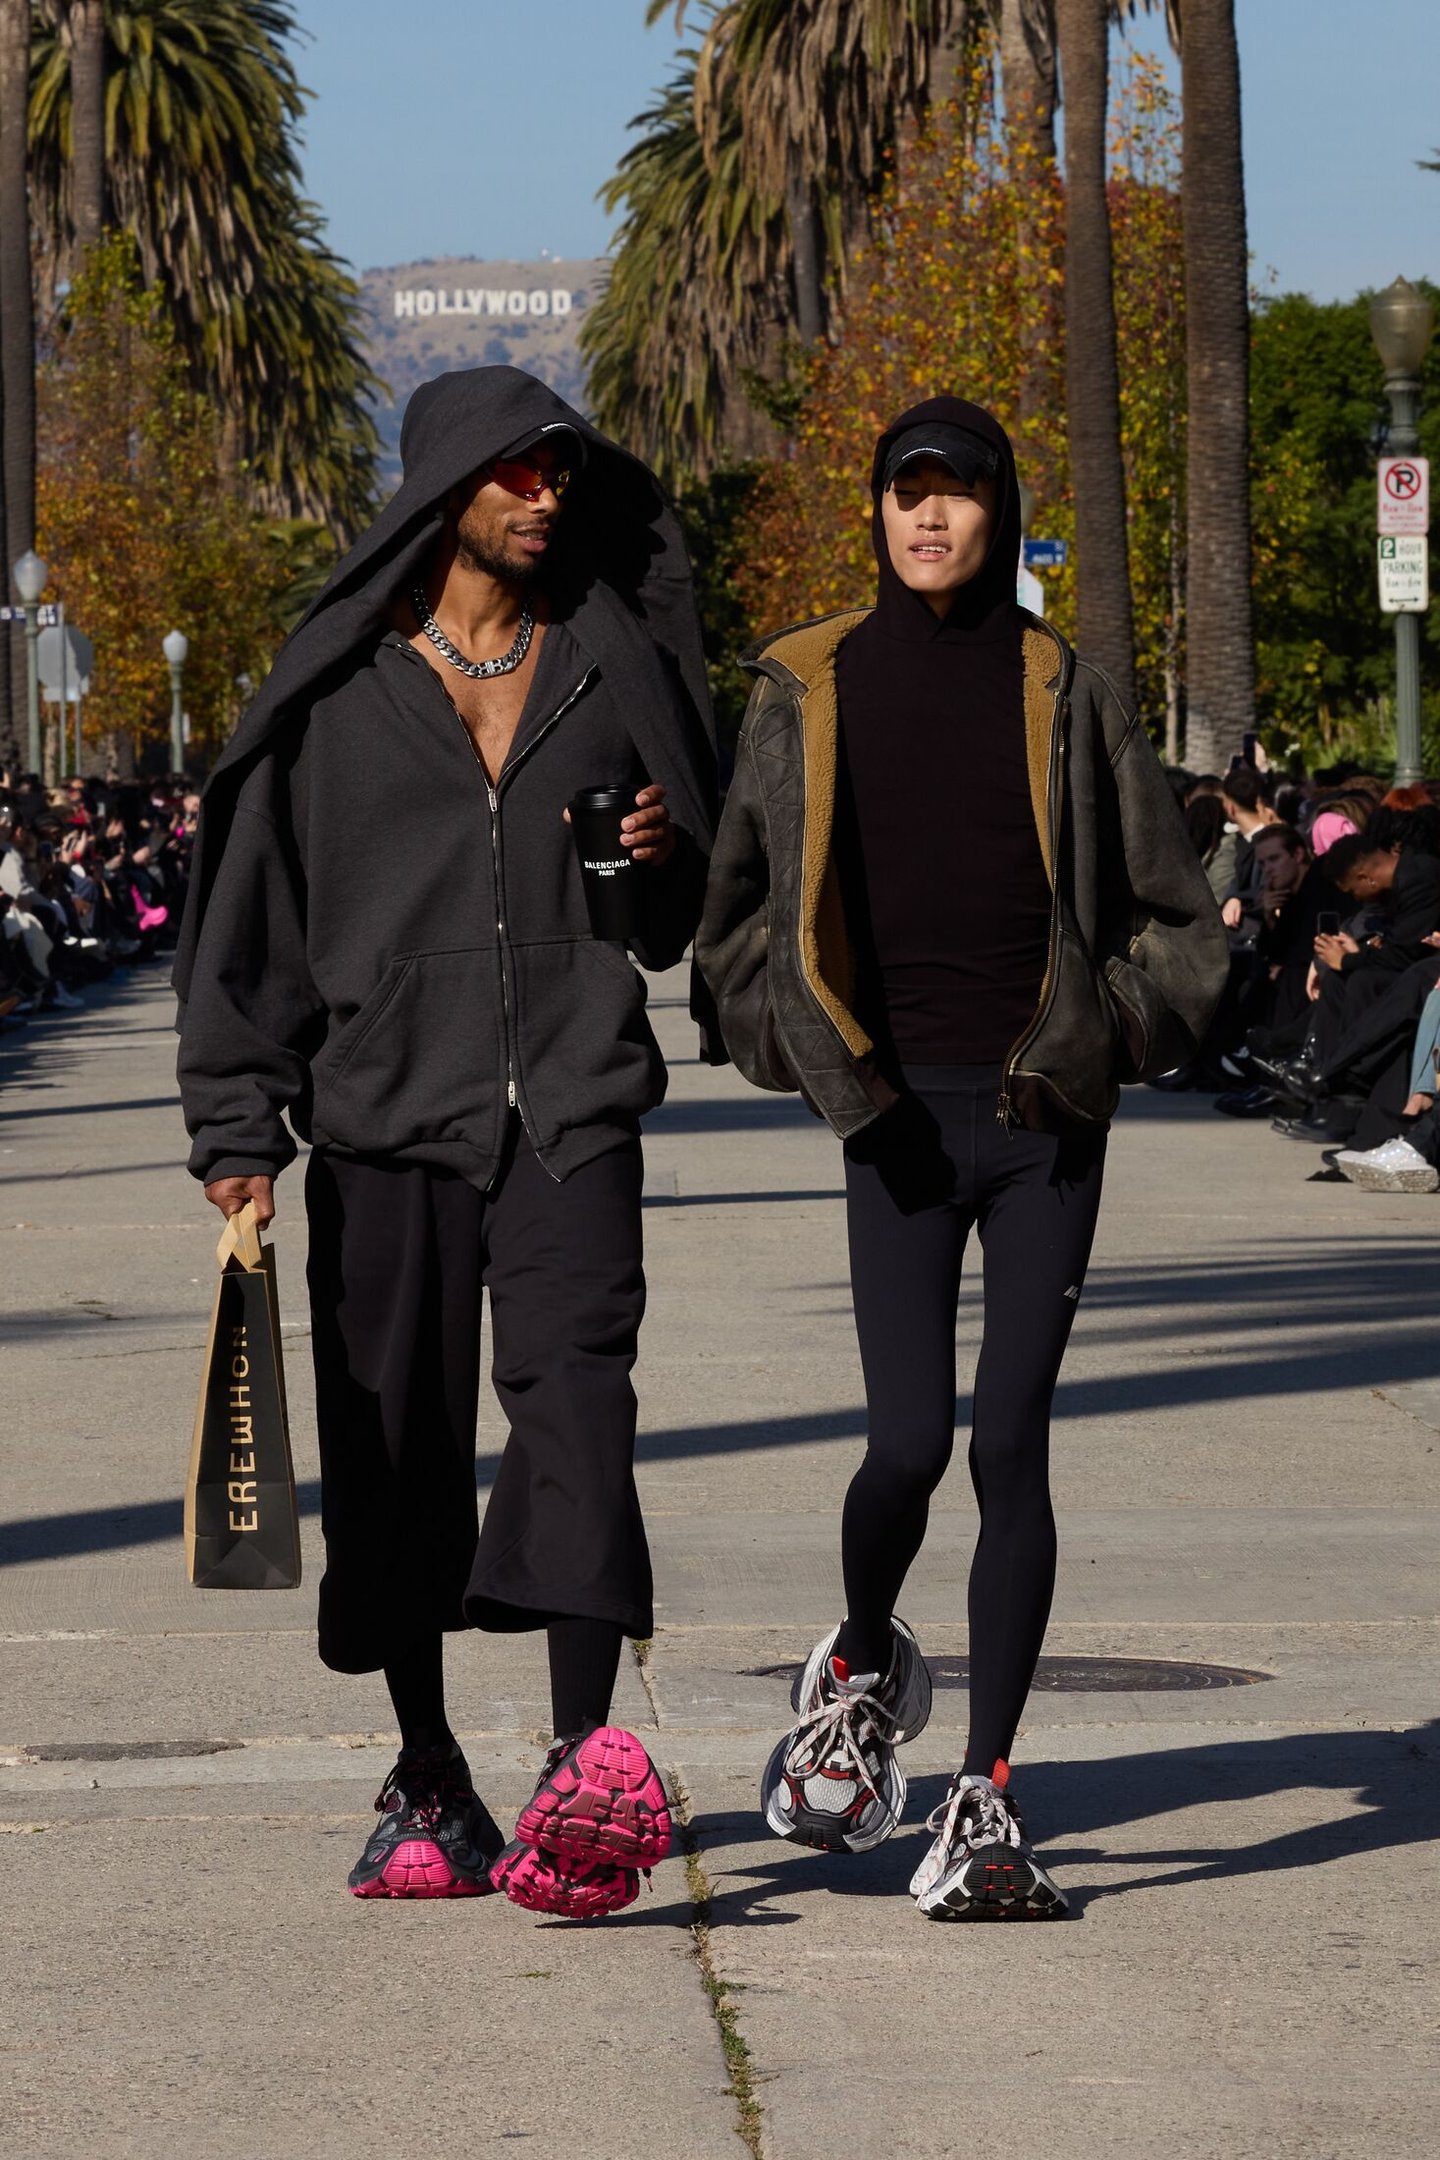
179, 613, 704, 1188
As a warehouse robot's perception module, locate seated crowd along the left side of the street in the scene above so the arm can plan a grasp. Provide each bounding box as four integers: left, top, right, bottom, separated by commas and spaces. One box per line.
0, 771, 201, 1028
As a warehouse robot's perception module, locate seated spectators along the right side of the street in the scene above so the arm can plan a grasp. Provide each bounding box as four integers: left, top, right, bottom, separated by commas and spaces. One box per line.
1155, 762, 1440, 1192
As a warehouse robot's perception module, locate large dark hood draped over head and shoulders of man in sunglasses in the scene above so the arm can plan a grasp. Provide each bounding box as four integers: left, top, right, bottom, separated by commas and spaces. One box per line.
175, 367, 715, 1002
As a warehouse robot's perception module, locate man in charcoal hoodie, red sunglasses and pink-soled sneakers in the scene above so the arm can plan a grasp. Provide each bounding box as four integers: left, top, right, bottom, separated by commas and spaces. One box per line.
175, 367, 715, 1914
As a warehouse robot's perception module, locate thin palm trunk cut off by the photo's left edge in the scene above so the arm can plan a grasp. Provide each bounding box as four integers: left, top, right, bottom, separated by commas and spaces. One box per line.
0, 0, 35, 768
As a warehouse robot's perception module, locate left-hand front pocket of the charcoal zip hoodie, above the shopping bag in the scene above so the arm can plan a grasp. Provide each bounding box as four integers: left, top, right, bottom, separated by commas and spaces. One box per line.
313, 946, 505, 1153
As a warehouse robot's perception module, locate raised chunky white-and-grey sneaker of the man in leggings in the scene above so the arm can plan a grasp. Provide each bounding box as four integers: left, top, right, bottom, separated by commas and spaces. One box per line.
760, 1620, 930, 1853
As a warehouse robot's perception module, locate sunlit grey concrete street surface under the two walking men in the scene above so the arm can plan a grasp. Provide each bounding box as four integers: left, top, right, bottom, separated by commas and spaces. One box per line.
0, 974, 1440, 2160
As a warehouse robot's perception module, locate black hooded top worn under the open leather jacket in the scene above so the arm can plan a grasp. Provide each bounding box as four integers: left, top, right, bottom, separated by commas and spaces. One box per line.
836, 397, 1051, 1067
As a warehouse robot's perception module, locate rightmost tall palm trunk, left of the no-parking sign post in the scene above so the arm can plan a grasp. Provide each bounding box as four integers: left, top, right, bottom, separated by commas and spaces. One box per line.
1181, 0, 1254, 773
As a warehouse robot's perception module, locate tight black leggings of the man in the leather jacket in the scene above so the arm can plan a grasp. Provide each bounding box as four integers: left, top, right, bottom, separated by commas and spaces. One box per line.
836, 1065, 1105, 1776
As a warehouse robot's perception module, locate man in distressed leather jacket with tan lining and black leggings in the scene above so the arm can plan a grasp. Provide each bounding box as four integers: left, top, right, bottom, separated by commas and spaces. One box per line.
695, 397, 1226, 1920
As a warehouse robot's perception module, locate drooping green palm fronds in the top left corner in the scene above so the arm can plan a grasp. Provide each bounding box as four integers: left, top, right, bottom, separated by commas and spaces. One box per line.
30, 0, 378, 531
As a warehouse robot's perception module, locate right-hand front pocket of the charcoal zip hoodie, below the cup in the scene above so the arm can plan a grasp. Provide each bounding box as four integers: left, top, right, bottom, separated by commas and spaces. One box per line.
510, 937, 665, 1147
